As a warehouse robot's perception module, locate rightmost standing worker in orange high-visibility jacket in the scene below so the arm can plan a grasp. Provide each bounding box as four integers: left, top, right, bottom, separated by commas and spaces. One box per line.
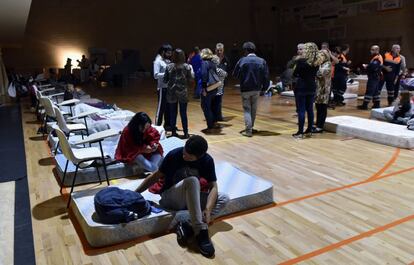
379, 44, 401, 106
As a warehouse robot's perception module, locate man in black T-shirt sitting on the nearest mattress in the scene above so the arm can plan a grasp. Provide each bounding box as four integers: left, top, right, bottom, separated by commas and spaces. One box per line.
136, 135, 229, 257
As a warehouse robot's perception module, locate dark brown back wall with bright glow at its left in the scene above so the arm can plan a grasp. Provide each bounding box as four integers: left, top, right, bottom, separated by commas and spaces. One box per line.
4, 0, 251, 69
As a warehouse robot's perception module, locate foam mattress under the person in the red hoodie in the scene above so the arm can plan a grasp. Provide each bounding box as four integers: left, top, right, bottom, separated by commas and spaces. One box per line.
55, 137, 185, 186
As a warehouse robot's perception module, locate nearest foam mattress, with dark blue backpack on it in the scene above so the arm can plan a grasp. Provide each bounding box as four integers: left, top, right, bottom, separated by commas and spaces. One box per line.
71, 162, 273, 247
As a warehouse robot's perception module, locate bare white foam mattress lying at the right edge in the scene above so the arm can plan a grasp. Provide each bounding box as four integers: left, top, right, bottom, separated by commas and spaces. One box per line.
325, 116, 414, 149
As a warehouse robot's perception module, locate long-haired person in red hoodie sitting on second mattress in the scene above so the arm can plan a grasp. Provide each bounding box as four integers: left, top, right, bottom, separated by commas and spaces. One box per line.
115, 112, 163, 172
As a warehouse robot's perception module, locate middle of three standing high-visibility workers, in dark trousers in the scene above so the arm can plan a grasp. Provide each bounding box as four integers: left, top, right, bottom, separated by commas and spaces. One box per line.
358, 45, 384, 110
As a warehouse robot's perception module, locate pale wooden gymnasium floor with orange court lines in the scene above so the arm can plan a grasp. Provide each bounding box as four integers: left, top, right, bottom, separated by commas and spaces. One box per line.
22, 81, 414, 265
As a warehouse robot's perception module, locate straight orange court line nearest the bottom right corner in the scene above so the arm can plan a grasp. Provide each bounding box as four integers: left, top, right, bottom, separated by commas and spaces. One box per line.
279, 214, 414, 265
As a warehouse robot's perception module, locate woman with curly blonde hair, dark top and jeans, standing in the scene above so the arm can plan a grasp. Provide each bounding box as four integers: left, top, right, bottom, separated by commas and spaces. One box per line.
292, 42, 325, 139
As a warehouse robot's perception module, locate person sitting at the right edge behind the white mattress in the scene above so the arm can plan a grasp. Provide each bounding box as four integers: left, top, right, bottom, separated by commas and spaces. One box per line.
384, 91, 414, 125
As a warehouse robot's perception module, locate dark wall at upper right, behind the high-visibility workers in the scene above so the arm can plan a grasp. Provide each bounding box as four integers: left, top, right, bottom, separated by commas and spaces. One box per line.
277, 0, 414, 67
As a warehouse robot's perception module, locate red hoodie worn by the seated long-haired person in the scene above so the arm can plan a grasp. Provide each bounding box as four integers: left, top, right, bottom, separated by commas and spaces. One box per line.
115, 126, 164, 164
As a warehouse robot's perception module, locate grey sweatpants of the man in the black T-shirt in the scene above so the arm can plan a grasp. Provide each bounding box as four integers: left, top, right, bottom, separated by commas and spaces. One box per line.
160, 177, 229, 234
